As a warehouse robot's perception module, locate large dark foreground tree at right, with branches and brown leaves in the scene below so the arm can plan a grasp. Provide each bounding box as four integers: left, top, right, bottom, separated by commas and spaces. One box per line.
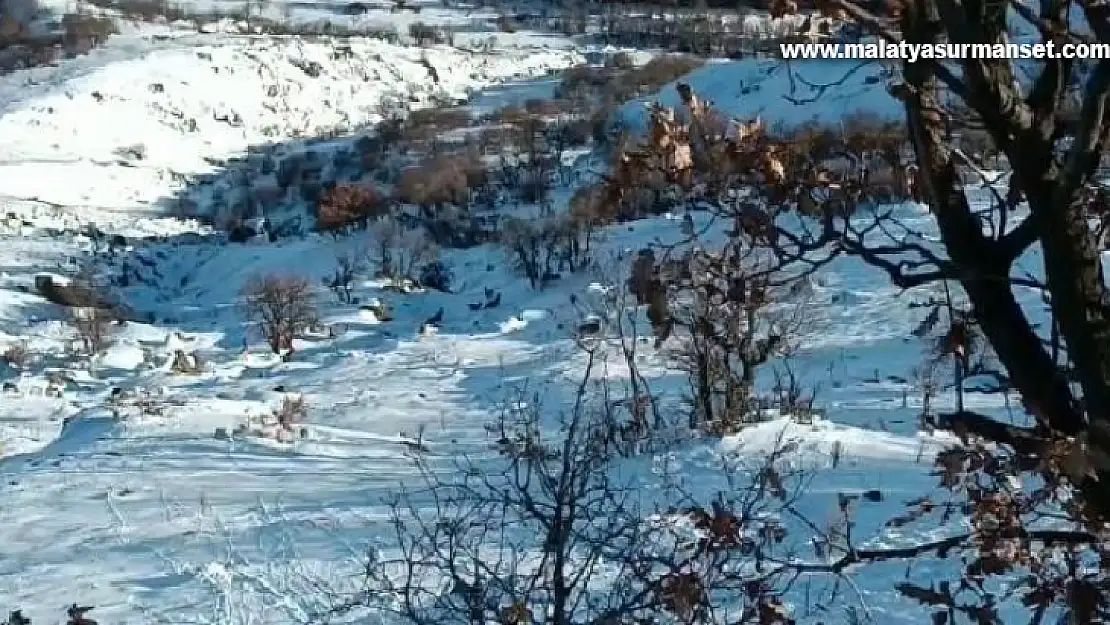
617, 0, 1110, 623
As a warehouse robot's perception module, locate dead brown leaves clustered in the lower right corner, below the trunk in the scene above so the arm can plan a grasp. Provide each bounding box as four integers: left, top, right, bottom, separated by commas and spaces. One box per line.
888, 436, 1110, 625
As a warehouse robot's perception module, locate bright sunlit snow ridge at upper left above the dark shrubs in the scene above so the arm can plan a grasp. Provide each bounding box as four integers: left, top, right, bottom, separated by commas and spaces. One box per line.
0, 37, 582, 212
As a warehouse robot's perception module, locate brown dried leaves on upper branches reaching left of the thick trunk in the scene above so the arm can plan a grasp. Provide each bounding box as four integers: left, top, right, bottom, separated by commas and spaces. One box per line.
605, 83, 909, 230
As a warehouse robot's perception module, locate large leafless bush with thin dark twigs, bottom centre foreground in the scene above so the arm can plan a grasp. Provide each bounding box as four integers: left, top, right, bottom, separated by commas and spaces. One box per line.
332, 349, 899, 625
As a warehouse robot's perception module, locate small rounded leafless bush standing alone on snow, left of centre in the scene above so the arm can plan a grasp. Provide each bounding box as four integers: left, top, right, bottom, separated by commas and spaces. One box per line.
241, 274, 319, 354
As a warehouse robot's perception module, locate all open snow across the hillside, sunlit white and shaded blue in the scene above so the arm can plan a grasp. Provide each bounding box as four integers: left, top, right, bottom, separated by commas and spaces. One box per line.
0, 6, 1025, 625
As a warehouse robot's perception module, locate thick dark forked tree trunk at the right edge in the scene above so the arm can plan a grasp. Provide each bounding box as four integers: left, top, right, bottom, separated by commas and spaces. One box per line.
904, 0, 1110, 518
